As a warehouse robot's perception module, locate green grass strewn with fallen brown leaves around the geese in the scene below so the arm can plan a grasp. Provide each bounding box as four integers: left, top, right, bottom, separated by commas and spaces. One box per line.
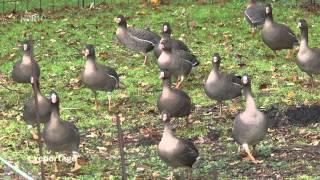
0, 1, 320, 179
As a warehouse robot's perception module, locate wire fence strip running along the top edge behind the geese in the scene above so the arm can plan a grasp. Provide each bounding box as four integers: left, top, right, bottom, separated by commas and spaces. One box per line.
0, 0, 320, 14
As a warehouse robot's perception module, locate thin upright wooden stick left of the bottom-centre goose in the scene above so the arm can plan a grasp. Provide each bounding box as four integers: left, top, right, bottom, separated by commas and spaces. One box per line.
115, 114, 128, 180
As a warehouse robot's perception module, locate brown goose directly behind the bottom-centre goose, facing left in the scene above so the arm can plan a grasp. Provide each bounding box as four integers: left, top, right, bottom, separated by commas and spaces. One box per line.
157, 70, 192, 125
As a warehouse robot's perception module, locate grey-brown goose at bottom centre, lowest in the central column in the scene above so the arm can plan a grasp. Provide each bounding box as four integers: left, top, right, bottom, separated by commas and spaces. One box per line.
158, 112, 199, 179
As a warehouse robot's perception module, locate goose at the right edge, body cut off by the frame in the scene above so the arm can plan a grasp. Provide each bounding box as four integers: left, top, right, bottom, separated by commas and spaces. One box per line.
296, 19, 320, 87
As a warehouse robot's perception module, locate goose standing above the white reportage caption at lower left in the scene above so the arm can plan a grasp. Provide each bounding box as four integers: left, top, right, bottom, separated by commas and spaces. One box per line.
43, 91, 81, 172
